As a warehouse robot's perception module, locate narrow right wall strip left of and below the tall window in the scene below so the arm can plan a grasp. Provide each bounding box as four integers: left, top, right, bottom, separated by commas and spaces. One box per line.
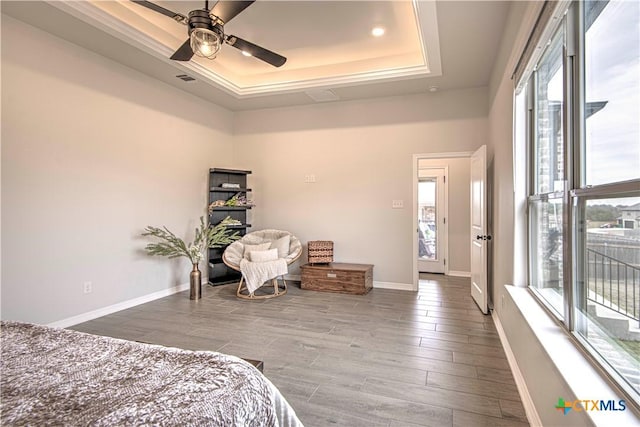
487, 2, 564, 425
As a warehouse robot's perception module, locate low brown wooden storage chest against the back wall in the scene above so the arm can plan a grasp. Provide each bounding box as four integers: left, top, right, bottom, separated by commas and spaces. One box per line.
300, 262, 373, 295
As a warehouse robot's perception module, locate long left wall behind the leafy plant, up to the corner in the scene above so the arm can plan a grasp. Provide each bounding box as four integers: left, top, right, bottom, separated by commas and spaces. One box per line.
2, 15, 232, 323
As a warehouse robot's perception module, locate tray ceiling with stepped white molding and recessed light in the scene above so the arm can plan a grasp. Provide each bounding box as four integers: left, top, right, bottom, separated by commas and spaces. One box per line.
1, 0, 509, 110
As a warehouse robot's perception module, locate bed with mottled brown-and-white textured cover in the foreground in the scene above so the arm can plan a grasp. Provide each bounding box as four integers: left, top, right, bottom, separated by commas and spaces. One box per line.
0, 321, 302, 427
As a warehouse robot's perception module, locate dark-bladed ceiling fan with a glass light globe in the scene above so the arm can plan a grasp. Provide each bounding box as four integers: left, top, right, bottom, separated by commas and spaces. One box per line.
131, 0, 287, 67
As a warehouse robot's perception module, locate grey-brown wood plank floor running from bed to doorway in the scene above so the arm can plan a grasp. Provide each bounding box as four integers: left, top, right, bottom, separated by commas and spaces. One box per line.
71, 275, 529, 427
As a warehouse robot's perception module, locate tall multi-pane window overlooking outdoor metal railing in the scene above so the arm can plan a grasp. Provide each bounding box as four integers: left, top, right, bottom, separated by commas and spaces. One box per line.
516, 0, 640, 402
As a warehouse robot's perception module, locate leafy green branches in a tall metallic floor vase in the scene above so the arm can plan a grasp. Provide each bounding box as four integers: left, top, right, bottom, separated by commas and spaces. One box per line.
142, 217, 240, 300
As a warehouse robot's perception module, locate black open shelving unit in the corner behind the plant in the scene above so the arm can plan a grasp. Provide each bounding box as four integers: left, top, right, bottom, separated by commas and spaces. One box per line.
207, 168, 251, 286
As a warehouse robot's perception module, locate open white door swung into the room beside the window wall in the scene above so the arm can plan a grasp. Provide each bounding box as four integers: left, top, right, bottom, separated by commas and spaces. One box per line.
471, 145, 491, 314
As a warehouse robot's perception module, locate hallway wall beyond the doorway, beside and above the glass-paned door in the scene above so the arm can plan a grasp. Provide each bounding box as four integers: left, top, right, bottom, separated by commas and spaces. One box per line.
418, 157, 471, 273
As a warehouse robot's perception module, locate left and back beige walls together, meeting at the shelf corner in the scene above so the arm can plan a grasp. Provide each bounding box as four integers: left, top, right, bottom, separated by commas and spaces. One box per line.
2, 11, 487, 323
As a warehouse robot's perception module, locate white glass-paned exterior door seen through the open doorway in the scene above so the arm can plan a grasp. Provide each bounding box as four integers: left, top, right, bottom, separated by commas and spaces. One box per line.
417, 168, 447, 273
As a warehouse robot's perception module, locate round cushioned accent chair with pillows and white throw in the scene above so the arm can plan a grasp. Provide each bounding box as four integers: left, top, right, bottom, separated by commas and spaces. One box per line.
222, 229, 302, 299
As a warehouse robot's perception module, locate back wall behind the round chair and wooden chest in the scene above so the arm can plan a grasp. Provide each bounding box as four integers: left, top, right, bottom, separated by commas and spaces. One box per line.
234, 88, 487, 284
